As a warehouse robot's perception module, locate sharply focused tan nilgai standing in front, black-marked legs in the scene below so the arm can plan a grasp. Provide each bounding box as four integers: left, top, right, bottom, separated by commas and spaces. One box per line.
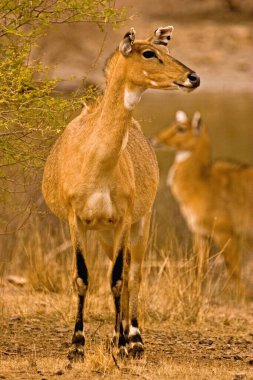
43, 26, 200, 358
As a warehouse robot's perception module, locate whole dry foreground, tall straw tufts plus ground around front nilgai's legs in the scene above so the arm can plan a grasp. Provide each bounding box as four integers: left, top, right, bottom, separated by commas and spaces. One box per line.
0, 212, 253, 380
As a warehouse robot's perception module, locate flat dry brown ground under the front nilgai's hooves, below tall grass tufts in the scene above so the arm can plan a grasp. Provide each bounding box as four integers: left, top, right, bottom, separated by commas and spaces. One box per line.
0, 284, 253, 380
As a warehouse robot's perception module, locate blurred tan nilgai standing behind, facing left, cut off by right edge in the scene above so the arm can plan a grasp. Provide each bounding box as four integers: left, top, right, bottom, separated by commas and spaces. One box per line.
156, 111, 253, 294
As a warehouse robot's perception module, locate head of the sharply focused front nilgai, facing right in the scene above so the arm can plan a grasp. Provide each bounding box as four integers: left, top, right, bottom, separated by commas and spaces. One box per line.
118, 26, 200, 91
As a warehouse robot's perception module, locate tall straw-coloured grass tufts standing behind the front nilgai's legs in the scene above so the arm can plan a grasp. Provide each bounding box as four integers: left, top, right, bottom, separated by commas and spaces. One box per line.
0, 212, 251, 323
